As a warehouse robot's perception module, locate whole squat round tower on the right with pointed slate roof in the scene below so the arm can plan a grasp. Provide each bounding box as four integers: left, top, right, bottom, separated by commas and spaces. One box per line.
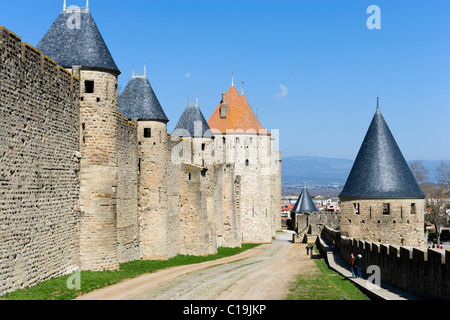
339, 100, 425, 248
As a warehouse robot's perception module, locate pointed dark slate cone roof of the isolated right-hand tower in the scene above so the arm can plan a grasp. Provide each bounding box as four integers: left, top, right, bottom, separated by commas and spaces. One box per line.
339, 109, 425, 198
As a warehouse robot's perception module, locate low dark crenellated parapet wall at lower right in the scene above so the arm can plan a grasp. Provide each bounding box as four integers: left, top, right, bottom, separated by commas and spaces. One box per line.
322, 227, 450, 300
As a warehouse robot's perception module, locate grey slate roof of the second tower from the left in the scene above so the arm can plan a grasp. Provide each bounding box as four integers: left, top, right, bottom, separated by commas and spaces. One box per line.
117, 75, 169, 122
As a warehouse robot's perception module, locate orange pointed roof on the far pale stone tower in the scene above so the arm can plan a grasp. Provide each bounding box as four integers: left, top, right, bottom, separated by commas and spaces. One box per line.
208, 86, 270, 135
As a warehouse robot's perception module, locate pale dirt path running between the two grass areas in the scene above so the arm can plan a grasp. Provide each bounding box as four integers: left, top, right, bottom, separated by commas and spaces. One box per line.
78, 233, 315, 300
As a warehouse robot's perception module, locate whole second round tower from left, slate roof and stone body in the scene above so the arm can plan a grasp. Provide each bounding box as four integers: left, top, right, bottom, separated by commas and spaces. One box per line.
118, 67, 171, 260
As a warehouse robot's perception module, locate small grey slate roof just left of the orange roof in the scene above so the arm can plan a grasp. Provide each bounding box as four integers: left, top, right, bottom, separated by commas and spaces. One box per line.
172, 104, 213, 138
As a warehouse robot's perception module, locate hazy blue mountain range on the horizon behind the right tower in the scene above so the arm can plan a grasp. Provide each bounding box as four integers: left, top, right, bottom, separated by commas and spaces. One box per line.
282, 156, 440, 188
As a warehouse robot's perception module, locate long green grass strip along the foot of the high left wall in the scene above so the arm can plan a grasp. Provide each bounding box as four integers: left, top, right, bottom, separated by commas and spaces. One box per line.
2, 244, 260, 300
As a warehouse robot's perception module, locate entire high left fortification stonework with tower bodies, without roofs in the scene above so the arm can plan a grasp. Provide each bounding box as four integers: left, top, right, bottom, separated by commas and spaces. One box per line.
0, 27, 281, 295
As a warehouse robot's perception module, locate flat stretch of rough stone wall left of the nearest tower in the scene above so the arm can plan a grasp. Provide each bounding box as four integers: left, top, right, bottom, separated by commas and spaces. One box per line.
0, 27, 80, 295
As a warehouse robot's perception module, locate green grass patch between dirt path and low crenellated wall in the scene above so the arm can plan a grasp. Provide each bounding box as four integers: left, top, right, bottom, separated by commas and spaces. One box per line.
286, 247, 370, 300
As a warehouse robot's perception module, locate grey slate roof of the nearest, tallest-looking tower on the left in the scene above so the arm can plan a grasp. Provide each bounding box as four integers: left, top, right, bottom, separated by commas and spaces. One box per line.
37, 8, 120, 74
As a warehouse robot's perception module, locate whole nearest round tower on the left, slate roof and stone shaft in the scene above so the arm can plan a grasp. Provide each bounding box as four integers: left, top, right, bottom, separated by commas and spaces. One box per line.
37, 2, 120, 271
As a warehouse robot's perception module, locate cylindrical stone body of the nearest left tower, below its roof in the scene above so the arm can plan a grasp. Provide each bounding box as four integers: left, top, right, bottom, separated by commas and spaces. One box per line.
80, 70, 119, 271
